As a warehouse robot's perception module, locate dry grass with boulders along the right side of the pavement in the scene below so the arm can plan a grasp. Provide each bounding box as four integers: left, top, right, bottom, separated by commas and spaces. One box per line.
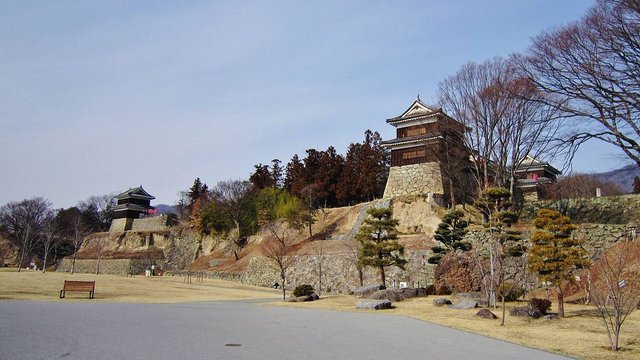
283, 296, 640, 359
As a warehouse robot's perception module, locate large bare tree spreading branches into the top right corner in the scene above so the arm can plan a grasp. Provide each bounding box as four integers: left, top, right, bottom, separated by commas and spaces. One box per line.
518, 0, 640, 165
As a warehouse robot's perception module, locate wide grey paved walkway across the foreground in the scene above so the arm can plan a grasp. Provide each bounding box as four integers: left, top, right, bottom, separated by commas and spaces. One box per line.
0, 301, 562, 360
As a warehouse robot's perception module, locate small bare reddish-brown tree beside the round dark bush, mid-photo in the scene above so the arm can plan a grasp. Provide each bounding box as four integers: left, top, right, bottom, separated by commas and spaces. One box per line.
262, 225, 295, 301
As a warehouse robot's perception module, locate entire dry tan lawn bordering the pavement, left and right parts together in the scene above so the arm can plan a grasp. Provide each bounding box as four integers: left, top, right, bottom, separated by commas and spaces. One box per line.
0, 269, 640, 359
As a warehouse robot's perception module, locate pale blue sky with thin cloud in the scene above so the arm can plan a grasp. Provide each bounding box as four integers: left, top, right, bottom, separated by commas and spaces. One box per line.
0, 0, 624, 207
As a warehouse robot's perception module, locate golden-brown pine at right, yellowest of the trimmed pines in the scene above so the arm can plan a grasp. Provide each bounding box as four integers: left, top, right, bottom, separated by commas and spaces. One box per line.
528, 209, 589, 317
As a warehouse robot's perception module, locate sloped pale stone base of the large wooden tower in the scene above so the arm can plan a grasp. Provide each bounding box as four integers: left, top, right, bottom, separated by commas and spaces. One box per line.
384, 162, 444, 200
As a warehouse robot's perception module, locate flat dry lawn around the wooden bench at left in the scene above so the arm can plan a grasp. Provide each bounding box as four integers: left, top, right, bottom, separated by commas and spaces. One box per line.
0, 269, 280, 303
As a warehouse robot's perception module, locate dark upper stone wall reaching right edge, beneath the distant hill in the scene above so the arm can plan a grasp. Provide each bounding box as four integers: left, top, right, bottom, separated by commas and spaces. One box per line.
520, 194, 640, 225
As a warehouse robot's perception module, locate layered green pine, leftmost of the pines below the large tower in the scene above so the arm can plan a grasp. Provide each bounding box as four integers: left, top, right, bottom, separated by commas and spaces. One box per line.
356, 208, 407, 286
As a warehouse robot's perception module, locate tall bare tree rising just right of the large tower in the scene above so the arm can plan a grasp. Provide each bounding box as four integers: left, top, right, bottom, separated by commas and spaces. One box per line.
439, 58, 560, 194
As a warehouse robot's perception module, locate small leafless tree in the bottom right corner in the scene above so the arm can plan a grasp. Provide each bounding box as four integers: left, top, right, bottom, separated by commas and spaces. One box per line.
587, 242, 640, 351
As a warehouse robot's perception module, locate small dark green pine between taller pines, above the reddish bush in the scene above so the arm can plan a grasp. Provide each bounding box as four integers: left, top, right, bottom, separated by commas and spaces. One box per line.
427, 210, 471, 264
